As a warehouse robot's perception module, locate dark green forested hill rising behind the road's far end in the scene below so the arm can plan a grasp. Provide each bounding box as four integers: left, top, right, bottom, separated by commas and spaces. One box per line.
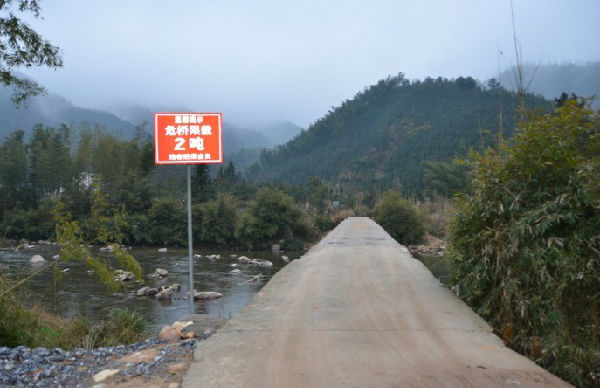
247, 74, 551, 194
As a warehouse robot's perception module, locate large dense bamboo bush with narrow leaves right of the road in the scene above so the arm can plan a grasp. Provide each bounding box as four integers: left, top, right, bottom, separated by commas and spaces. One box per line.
450, 100, 600, 386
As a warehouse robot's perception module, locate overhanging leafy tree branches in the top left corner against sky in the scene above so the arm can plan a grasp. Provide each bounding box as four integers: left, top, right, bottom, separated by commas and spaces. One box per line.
0, 0, 62, 103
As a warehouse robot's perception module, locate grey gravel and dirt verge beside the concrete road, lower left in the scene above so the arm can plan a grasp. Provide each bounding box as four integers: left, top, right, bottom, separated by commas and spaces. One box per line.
0, 314, 225, 388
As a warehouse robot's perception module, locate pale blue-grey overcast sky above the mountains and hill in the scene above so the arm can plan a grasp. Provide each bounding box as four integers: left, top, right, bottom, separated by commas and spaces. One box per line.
21, 0, 600, 127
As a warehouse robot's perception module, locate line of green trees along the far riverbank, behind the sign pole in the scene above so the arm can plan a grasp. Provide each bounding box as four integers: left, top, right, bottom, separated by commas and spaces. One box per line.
0, 123, 344, 249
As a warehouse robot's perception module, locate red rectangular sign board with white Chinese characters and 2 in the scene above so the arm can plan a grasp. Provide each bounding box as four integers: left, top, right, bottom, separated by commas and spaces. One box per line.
154, 113, 223, 164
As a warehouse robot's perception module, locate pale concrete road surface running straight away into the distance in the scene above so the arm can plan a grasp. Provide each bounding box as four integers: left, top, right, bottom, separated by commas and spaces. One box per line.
183, 218, 569, 388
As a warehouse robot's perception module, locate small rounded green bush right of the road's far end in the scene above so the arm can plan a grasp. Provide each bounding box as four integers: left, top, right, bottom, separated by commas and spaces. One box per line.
375, 191, 425, 245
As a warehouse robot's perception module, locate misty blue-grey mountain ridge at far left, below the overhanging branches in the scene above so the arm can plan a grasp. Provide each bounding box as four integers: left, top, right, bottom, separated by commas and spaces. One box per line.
0, 86, 135, 138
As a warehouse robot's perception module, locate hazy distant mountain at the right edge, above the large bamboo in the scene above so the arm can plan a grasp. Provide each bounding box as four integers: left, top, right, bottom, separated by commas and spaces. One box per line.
500, 61, 600, 108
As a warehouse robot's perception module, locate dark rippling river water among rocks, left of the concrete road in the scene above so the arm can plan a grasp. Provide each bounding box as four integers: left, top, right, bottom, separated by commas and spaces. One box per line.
0, 247, 299, 330
